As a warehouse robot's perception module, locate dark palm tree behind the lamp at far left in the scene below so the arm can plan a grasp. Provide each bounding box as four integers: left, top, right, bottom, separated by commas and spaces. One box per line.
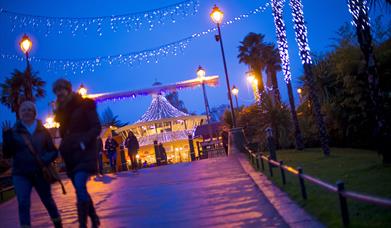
0, 67, 46, 118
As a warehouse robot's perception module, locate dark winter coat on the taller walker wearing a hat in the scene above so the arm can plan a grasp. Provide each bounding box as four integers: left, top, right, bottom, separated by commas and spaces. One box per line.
55, 94, 101, 177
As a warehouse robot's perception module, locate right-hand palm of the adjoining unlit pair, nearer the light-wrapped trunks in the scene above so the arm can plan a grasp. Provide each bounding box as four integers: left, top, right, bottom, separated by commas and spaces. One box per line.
263, 44, 281, 105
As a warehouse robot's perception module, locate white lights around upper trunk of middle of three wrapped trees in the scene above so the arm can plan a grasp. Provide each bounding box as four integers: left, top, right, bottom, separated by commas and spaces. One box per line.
290, 0, 312, 64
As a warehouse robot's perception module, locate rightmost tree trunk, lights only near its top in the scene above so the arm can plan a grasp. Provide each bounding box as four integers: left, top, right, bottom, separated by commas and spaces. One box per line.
348, 0, 391, 163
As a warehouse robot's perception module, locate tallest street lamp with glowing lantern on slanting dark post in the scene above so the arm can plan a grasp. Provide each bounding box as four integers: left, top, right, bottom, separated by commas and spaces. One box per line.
210, 5, 236, 128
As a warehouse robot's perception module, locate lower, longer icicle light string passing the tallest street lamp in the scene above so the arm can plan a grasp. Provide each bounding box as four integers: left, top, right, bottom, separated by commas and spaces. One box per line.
0, 3, 269, 74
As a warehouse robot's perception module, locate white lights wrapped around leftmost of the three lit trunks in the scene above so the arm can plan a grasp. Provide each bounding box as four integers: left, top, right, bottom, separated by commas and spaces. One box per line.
271, 0, 292, 84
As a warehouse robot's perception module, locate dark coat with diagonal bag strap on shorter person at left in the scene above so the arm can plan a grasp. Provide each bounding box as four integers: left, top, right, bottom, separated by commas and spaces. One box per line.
3, 121, 58, 176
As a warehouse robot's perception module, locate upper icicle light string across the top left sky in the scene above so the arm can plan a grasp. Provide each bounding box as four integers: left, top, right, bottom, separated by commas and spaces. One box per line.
0, 0, 199, 36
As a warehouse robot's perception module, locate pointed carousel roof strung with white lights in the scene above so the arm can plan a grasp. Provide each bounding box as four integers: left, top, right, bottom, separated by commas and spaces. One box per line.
135, 94, 189, 123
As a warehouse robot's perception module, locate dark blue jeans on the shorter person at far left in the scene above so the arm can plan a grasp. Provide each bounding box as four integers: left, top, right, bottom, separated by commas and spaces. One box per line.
12, 174, 60, 226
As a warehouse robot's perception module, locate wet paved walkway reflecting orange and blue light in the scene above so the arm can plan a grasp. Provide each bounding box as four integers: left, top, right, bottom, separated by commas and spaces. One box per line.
0, 156, 312, 228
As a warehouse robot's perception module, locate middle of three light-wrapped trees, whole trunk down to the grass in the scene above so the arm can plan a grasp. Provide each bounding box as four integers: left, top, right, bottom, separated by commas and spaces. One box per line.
290, 0, 330, 156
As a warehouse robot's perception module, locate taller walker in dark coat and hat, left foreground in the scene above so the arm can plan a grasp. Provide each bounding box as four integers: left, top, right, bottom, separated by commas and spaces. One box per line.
53, 79, 101, 227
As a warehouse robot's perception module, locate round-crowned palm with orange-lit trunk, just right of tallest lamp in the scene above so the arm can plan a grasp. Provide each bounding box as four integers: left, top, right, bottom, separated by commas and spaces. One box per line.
238, 32, 267, 94
